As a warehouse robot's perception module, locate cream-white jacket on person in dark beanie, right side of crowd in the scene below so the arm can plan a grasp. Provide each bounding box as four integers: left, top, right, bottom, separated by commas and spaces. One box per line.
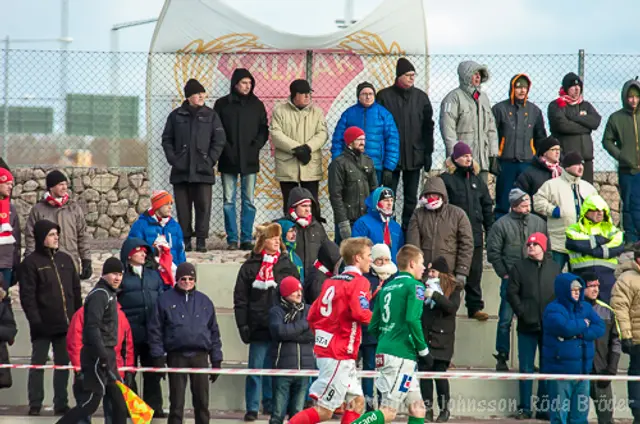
533, 170, 598, 253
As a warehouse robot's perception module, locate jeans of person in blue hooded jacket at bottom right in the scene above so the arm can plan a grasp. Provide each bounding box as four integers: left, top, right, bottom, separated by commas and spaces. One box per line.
547, 380, 591, 424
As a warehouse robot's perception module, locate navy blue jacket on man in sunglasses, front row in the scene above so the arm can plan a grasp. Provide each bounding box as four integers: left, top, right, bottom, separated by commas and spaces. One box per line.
149, 285, 222, 365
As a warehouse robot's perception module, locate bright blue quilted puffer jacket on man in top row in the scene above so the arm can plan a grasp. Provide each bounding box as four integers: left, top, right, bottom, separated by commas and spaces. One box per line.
331, 103, 400, 171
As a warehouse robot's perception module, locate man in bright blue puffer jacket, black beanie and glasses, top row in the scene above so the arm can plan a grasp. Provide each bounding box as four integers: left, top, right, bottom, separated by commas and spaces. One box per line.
331, 81, 400, 187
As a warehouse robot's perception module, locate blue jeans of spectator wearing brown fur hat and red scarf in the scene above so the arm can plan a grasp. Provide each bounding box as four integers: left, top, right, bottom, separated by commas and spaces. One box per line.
244, 342, 273, 412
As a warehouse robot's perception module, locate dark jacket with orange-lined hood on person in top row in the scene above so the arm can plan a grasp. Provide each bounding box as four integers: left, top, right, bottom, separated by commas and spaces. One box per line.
492, 74, 547, 162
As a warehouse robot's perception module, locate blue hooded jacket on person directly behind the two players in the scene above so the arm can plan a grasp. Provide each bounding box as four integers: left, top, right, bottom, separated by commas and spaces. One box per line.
351, 187, 404, 263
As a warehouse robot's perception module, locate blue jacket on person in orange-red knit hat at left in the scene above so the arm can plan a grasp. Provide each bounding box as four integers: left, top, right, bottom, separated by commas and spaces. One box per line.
129, 211, 187, 265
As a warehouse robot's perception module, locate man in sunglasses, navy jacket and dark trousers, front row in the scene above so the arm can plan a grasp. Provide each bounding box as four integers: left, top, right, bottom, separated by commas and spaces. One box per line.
149, 262, 222, 423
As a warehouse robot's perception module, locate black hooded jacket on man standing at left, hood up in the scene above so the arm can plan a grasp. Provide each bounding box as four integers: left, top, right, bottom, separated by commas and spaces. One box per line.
18, 220, 82, 340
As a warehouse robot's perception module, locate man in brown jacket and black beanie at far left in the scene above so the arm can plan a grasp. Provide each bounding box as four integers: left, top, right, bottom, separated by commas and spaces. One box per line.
24, 169, 93, 280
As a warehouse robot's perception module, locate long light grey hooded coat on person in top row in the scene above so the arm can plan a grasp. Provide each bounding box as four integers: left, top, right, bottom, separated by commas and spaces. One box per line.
440, 61, 498, 171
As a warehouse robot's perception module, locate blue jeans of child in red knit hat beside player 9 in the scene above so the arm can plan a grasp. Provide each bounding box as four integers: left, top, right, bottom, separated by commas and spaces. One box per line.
269, 377, 309, 424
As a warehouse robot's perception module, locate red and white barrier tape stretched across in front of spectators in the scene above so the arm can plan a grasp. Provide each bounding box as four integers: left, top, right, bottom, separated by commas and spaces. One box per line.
0, 364, 640, 381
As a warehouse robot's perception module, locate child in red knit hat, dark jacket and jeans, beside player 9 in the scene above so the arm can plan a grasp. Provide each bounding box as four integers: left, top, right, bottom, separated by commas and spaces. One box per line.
269, 277, 316, 424
